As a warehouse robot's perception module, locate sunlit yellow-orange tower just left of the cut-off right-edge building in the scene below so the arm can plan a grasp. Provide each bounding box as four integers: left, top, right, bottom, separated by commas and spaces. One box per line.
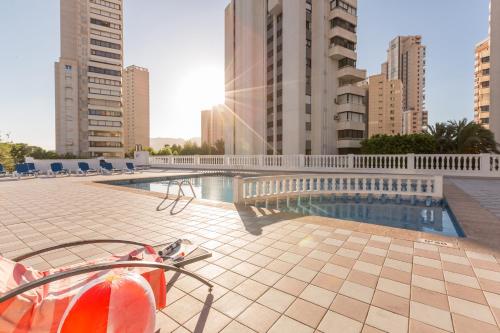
474, 39, 490, 128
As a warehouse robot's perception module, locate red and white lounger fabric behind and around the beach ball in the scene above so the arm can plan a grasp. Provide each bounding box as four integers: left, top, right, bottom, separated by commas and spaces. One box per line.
0, 247, 166, 333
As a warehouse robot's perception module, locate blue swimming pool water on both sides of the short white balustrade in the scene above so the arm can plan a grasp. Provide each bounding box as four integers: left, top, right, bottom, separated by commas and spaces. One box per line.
108, 175, 464, 237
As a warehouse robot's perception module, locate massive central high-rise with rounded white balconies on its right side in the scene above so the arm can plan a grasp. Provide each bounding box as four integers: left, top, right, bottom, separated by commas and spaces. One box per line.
225, 0, 366, 154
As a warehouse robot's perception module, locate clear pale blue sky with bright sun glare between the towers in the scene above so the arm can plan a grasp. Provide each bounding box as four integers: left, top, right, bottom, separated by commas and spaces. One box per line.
0, 0, 488, 149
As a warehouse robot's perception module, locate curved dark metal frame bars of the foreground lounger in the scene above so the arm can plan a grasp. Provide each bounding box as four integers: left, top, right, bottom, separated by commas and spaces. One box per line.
0, 239, 213, 303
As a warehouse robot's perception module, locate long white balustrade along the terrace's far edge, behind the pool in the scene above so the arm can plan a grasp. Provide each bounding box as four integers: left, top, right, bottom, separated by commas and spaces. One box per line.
150, 154, 500, 177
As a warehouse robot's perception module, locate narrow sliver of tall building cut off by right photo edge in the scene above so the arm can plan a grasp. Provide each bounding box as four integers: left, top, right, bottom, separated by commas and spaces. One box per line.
490, 0, 500, 142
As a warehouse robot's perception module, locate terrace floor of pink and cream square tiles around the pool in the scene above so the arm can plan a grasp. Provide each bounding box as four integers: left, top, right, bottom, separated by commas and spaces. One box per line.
0, 172, 500, 333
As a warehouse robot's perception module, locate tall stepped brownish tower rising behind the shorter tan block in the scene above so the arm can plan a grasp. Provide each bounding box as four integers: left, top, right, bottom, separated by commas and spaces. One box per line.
387, 36, 428, 134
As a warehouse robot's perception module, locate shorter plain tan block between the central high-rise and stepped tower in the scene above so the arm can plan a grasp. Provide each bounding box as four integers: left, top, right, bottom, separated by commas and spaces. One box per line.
368, 72, 403, 138
